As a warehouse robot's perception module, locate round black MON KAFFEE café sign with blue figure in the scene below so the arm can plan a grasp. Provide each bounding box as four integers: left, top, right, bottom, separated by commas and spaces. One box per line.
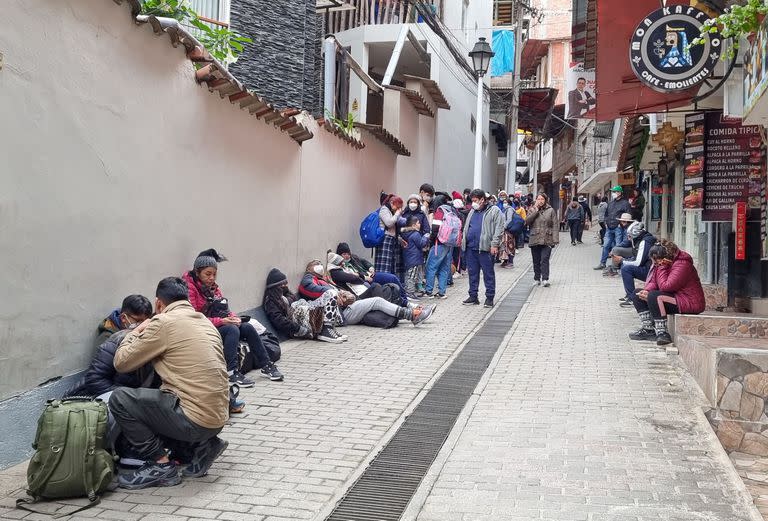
629, 5, 723, 92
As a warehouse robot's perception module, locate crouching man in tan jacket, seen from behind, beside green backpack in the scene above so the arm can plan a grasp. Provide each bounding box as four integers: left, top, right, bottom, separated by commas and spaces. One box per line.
109, 277, 229, 489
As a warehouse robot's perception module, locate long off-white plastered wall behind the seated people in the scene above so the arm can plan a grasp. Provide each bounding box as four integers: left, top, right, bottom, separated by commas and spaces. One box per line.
0, 0, 400, 399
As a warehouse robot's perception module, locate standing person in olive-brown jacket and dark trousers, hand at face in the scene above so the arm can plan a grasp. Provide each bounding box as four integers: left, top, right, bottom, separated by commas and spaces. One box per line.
525, 193, 560, 288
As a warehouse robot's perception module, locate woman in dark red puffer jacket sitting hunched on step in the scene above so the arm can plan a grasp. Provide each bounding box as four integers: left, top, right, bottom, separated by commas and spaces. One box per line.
629, 239, 704, 346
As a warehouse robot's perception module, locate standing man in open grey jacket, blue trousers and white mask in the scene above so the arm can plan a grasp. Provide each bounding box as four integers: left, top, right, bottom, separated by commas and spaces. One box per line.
462, 188, 504, 308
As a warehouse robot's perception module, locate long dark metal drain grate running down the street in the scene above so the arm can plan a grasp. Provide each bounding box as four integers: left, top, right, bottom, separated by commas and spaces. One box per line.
326, 275, 532, 521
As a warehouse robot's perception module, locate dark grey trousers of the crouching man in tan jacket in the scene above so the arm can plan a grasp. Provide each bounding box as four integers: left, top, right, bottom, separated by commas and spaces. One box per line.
109, 387, 222, 461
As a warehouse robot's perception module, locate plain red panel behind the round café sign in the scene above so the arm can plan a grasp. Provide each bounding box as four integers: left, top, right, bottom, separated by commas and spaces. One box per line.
587, 0, 699, 121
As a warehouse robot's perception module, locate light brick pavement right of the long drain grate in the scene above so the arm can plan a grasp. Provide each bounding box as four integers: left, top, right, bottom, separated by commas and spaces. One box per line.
412, 236, 761, 521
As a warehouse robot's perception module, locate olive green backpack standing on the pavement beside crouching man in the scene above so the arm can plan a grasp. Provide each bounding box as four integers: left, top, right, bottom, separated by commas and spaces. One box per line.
16, 397, 115, 517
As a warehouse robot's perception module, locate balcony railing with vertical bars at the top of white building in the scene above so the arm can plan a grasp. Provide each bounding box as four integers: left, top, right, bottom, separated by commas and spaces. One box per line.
325, 0, 445, 33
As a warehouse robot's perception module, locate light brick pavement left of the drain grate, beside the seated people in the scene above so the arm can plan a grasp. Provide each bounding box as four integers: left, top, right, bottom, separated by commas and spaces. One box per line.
0, 249, 530, 521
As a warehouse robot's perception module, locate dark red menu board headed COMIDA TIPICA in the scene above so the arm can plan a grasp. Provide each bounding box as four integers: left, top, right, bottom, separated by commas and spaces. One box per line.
702, 112, 765, 221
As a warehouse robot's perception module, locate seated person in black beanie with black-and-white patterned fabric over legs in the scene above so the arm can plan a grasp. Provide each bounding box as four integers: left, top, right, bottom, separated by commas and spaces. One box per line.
263, 268, 347, 344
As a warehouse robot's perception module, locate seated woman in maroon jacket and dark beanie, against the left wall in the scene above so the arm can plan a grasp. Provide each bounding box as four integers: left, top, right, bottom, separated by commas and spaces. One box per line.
182, 249, 283, 387
